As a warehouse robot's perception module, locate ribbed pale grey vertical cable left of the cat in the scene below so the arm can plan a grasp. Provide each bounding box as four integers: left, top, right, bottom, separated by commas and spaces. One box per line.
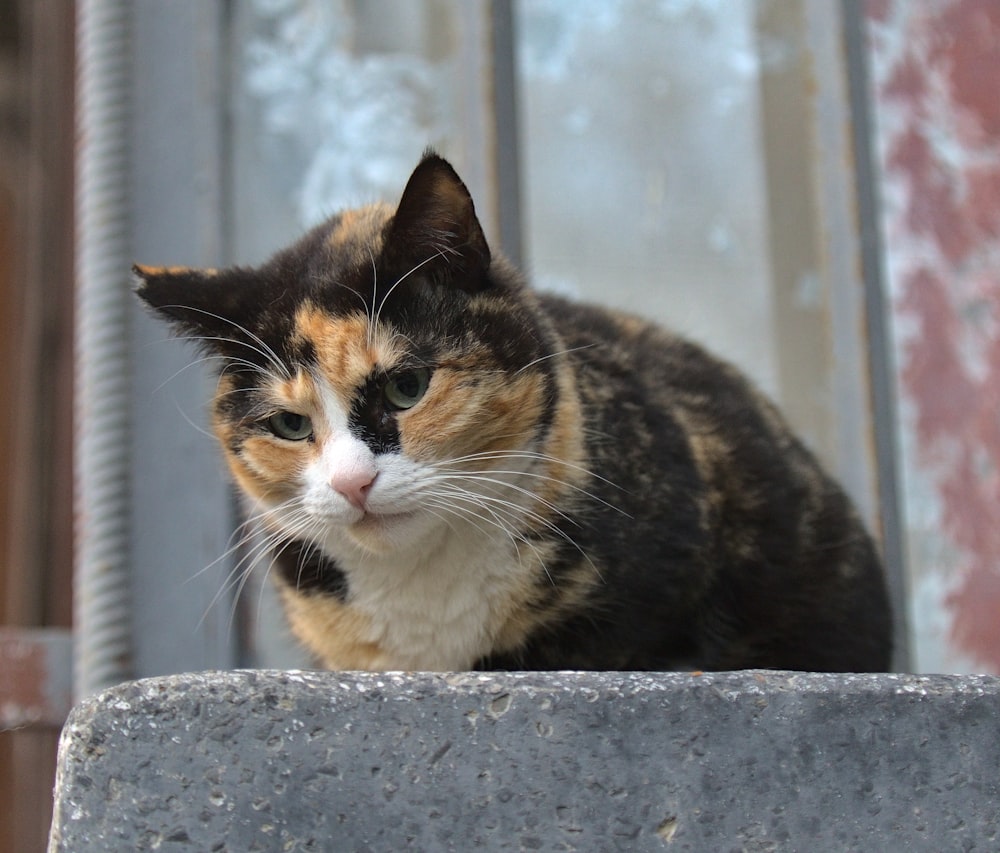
74, 0, 133, 699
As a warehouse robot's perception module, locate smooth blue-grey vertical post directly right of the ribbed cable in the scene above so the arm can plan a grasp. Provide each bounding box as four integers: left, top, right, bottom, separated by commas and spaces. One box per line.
129, 0, 237, 675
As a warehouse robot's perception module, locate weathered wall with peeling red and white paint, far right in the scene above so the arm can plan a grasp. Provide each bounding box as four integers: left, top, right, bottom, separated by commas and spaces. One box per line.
866, 0, 1000, 673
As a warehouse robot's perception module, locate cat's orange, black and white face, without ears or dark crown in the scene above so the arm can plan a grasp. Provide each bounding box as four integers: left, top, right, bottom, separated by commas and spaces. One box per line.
215, 290, 546, 551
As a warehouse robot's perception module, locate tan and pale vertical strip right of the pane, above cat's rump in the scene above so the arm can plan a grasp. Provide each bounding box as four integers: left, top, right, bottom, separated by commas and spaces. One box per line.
757, 0, 881, 530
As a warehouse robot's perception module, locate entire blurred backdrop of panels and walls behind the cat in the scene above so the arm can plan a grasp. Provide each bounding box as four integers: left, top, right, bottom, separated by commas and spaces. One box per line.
0, 0, 1000, 851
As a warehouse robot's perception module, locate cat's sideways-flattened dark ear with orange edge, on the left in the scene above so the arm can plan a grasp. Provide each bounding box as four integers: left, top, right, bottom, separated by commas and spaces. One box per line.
132, 264, 240, 341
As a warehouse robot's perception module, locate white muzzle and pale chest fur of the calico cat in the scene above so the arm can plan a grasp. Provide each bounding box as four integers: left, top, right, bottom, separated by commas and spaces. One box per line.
262, 376, 568, 670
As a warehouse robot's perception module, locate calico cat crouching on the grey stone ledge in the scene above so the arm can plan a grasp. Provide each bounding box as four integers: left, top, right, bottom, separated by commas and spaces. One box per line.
135, 152, 890, 671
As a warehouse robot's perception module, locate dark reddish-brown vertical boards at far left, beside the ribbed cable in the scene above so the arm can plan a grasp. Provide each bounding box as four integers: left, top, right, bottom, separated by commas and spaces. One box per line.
0, 0, 74, 853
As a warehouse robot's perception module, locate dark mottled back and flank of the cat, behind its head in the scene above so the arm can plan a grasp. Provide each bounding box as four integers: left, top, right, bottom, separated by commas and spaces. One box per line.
524, 295, 891, 670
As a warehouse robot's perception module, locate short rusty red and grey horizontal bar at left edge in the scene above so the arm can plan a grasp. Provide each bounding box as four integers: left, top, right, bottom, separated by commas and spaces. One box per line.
0, 628, 73, 731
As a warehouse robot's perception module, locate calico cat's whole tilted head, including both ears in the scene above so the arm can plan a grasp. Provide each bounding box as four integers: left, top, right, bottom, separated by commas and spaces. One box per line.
135, 153, 565, 552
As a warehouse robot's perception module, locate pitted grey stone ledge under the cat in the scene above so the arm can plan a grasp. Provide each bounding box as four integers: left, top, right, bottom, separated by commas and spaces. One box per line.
50, 672, 1000, 853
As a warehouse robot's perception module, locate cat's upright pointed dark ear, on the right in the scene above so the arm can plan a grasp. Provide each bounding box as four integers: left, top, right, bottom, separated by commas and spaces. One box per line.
385, 152, 491, 293
